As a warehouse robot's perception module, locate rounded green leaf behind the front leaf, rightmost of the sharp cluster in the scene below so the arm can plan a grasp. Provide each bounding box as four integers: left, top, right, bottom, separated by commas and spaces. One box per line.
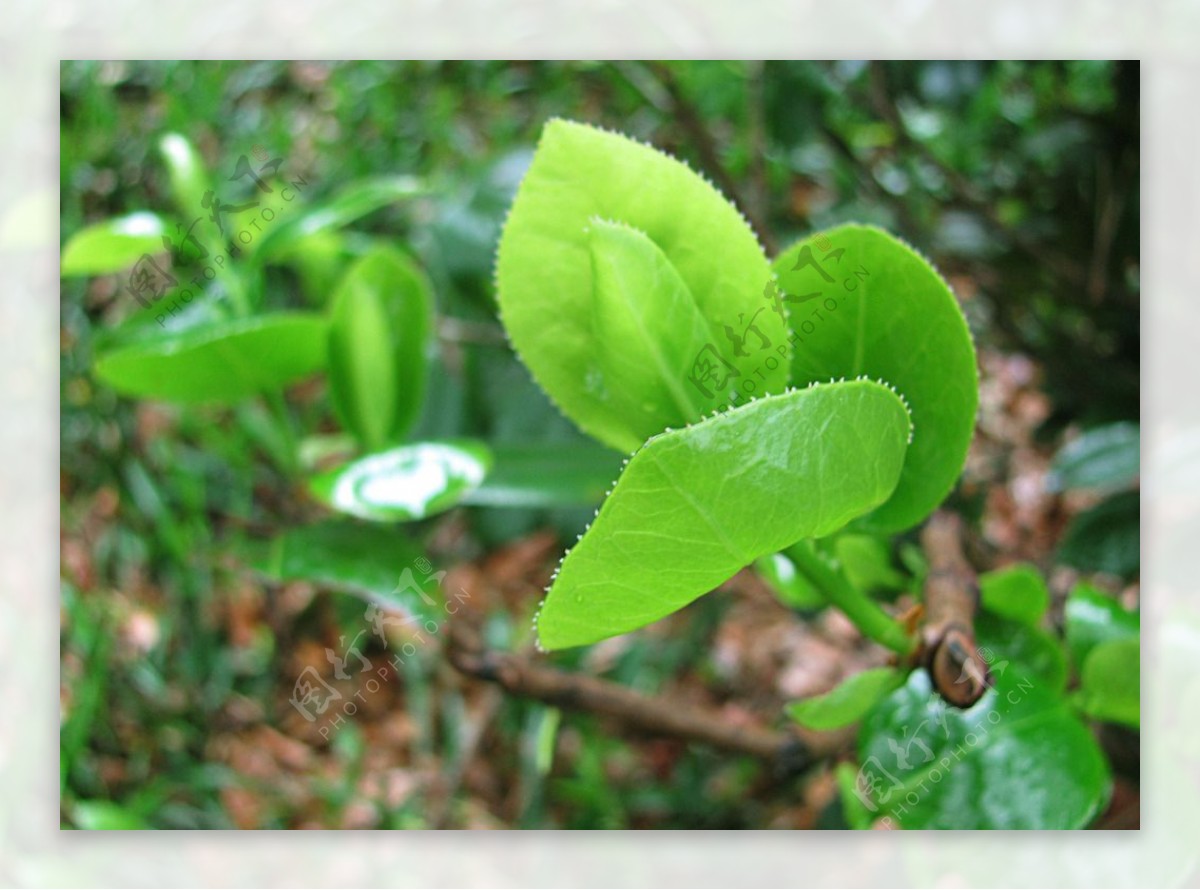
774, 225, 978, 533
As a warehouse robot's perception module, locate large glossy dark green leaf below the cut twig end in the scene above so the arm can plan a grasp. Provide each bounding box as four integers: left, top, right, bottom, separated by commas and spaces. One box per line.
856, 663, 1111, 829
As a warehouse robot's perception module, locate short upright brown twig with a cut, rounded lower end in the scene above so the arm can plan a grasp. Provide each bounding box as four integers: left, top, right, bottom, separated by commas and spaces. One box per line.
917, 511, 989, 708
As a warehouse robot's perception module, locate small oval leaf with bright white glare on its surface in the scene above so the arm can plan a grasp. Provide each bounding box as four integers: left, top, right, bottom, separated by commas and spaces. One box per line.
310, 441, 492, 522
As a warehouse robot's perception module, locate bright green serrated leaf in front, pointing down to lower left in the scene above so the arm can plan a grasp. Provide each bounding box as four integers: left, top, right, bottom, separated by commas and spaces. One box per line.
538, 380, 910, 649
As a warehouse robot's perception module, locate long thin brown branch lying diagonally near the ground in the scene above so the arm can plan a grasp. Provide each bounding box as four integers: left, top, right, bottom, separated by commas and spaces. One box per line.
446, 615, 852, 774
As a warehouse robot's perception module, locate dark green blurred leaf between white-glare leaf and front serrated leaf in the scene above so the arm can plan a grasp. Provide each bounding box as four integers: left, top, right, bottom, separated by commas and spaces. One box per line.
463, 443, 622, 507
